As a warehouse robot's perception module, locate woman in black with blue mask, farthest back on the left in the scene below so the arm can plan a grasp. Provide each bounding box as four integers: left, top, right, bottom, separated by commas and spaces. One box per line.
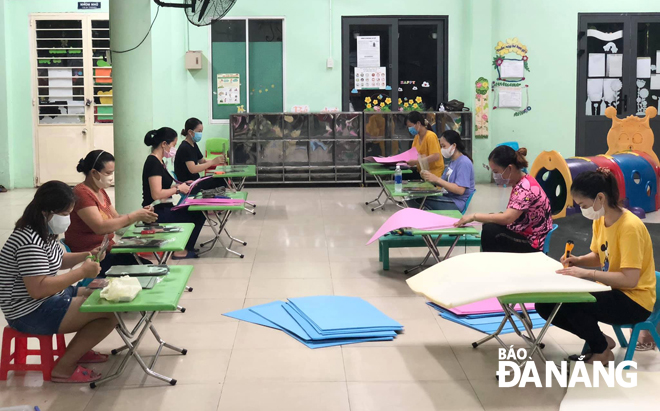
174, 117, 225, 194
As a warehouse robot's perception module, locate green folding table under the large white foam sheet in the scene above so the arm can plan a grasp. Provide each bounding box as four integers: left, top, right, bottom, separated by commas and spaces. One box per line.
472, 292, 596, 365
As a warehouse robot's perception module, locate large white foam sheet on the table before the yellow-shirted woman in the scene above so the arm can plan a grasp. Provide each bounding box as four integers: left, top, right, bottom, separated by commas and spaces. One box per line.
407, 252, 610, 308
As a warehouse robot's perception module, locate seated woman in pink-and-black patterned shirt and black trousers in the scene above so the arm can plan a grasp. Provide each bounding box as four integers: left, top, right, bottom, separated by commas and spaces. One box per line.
456, 146, 552, 253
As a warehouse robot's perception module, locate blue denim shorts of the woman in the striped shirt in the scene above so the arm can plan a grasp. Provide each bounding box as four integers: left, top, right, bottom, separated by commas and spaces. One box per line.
7, 286, 78, 335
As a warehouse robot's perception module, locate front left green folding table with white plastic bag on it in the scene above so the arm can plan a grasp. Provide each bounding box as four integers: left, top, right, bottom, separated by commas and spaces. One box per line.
80, 265, 193, 388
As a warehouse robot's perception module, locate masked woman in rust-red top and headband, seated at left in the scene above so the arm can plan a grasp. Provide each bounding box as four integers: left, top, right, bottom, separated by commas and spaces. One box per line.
64, 150, 158, 276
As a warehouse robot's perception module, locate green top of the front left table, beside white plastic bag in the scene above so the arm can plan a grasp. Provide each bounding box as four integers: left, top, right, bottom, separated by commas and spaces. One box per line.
80, 265, 193, 313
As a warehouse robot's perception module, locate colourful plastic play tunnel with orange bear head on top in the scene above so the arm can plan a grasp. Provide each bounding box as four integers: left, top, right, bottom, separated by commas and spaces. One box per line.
530, 107, 660, 219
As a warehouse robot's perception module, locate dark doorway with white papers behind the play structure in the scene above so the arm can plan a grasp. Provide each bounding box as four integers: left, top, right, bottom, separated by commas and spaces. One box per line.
575, 13, 660, 156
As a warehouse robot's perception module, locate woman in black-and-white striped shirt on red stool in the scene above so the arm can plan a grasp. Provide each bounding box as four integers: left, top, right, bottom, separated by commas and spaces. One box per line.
0, 181, 117, 383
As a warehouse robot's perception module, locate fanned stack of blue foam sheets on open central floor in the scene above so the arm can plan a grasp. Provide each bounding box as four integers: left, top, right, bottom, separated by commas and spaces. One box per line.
223, 296, 403, 348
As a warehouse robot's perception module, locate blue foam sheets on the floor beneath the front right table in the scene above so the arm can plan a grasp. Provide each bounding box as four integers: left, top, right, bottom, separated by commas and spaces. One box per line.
427, 302, 545, 334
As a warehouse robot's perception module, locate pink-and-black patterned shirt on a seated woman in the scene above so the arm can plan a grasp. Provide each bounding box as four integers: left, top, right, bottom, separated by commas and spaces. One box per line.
506, 175, 552, 251
